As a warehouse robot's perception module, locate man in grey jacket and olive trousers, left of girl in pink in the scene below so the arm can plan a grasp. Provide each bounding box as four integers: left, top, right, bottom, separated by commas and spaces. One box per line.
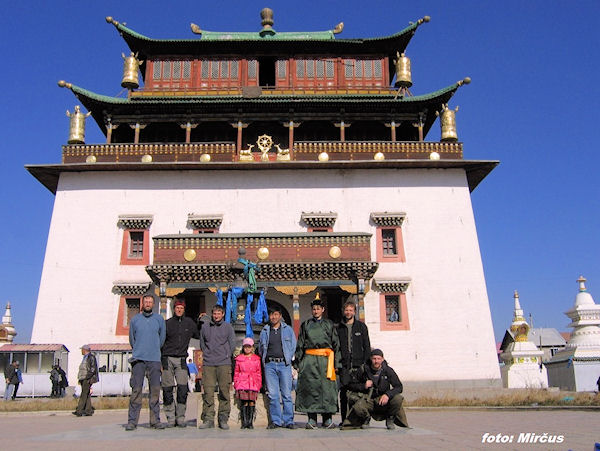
199, 305, 235, 429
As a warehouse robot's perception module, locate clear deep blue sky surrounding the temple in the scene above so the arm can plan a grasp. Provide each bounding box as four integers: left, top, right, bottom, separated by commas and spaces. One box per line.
0, 0, 600, 343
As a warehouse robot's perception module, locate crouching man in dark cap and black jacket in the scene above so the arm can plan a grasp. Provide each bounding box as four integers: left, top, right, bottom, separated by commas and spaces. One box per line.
341, 349, 408, 429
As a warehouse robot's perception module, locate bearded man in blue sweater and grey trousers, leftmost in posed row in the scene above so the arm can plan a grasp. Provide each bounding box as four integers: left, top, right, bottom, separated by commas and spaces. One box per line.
125, 295, 166, 431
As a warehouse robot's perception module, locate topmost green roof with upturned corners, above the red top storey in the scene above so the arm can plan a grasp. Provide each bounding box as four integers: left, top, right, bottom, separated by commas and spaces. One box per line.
106, 16, 429, 60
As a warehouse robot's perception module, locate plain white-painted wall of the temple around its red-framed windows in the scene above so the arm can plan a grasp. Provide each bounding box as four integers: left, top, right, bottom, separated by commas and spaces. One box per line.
32, 169, 500, 386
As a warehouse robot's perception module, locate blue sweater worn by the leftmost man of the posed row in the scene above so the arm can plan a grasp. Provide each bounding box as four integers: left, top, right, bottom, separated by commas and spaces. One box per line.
129, 312, 166, 362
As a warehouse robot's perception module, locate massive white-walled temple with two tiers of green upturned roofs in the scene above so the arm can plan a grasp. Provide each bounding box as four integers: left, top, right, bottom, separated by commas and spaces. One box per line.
27, 8, 501, 387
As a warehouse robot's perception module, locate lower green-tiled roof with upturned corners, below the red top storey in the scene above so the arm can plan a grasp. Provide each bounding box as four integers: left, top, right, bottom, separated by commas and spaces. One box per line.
59, 79, 469, 139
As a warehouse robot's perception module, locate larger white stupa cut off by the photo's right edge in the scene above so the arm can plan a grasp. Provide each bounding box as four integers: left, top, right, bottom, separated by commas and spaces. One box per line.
547, 276, 600, 391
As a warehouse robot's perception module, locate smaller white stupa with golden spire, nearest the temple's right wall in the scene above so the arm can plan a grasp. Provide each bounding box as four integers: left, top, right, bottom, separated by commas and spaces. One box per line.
500, 290, 548, 388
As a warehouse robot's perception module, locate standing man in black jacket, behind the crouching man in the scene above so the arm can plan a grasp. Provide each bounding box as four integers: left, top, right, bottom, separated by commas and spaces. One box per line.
338, 301, 371, 421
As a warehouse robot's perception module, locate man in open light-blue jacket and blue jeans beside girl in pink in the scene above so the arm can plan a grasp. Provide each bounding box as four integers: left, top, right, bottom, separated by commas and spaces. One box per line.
258, 307, 296, 429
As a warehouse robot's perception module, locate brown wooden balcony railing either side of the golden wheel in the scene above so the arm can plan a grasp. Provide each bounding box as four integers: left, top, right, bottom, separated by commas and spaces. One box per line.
62, 141, 463, 164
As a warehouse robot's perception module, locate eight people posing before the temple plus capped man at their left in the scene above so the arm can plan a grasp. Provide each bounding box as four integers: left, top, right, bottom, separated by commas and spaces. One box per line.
74, 295, 408, 431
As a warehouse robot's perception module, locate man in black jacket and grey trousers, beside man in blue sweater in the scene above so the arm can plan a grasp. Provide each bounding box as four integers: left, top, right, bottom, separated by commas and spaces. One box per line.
161, 299, 199, 427
